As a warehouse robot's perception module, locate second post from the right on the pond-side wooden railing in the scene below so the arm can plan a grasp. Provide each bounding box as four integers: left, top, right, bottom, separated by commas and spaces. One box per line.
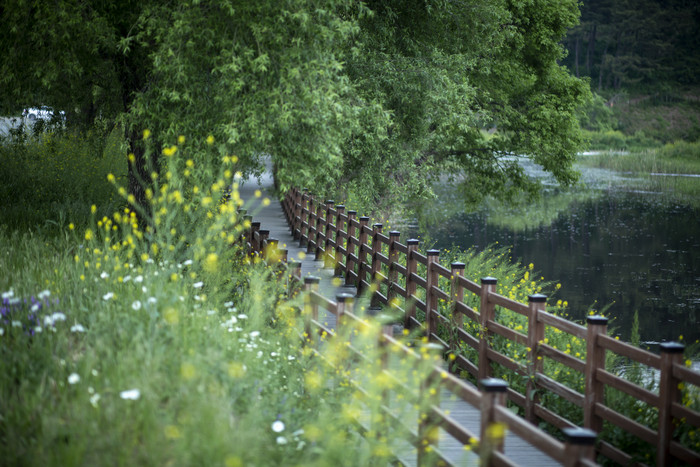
583, 315, 608, 433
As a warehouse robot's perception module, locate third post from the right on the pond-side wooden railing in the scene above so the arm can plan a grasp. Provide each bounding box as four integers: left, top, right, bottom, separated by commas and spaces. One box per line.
525, 294, 547, 423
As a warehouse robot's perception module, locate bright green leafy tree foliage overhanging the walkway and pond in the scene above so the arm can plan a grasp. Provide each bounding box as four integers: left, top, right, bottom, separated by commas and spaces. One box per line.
0, 0, 589, 210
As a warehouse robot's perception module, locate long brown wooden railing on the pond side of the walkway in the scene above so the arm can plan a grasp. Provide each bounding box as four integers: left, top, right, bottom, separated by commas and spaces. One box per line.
278, 190, 700, 465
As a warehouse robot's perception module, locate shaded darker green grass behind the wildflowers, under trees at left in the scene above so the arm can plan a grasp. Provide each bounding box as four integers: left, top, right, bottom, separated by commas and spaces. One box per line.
0, 127, 127, 232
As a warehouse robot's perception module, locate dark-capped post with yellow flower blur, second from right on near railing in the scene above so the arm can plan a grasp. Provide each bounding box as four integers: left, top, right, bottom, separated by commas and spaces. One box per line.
479, 378, 508, 465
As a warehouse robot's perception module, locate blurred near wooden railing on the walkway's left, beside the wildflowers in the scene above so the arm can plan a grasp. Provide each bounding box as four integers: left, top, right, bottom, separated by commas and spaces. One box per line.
304, 276, 597, 467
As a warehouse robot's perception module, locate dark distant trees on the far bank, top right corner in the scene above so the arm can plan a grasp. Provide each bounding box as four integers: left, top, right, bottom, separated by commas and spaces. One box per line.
563, 0, 700, 90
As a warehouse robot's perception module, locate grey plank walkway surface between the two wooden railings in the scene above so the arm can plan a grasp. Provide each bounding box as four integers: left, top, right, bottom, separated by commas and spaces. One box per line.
239, 171, 560, 467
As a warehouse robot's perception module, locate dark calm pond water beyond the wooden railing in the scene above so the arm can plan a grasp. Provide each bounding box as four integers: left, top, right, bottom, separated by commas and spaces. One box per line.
410, 191, 700, 345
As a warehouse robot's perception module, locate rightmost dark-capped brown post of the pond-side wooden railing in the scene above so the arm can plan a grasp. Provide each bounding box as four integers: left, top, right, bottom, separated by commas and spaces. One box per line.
656, 342, 685, 465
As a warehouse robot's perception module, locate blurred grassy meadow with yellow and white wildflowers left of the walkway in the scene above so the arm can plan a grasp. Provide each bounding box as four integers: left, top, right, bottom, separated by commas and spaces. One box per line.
0, 132, 442, 466
